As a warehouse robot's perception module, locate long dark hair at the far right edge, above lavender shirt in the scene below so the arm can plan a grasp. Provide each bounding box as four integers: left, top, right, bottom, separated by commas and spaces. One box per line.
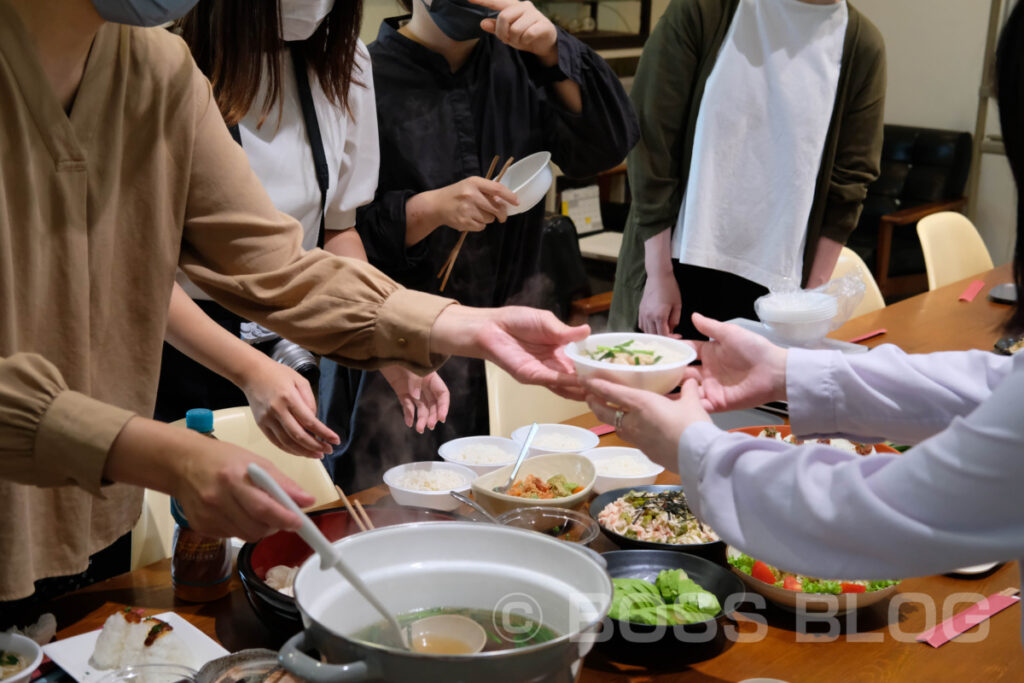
999, 2, 1024, 334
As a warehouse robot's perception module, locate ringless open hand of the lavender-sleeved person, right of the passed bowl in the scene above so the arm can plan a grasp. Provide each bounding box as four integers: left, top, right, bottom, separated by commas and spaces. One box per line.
684, 313, 786, 413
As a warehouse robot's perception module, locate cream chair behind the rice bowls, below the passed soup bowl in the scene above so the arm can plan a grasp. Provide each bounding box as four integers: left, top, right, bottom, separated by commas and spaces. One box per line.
484, 360, 590, 436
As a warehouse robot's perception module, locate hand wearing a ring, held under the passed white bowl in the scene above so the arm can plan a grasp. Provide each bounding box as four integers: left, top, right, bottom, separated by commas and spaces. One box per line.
581, 378, 711, 472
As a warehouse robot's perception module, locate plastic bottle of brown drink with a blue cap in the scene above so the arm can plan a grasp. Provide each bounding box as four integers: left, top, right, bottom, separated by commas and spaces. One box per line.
171, 409, 231, 602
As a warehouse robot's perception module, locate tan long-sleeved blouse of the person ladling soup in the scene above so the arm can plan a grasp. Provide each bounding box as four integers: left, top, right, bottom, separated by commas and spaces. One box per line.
0, 5, 452, 600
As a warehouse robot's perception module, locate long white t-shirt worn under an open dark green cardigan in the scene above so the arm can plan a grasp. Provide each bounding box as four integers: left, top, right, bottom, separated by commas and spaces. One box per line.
672, 0, 848, 296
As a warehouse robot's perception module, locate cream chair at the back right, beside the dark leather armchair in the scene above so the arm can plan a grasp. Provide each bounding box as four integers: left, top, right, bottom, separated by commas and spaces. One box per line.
918, 211, 992, 290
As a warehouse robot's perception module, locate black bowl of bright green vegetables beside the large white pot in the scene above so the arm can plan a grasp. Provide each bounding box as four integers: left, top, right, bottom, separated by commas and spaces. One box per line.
600, 550, 744, 665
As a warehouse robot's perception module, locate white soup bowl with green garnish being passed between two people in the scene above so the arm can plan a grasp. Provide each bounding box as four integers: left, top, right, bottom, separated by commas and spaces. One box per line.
565, 332, 697, 394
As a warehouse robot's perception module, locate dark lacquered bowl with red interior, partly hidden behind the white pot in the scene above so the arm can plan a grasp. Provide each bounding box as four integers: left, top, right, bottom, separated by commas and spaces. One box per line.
239, 506, 459, 635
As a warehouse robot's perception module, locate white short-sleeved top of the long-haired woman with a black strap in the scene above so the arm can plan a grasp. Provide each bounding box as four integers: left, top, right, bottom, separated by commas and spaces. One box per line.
178, 41, 380, 299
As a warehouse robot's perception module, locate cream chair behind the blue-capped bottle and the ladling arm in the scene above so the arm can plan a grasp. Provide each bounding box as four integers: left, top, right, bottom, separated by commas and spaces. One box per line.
131, 405, 338, 569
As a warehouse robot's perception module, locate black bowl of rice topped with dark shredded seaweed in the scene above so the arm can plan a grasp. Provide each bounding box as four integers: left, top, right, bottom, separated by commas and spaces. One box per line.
590, 484, 726, 566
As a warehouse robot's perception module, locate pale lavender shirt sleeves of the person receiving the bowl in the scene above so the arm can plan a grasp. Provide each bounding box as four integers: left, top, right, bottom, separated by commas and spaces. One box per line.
679, 350, 1024, 579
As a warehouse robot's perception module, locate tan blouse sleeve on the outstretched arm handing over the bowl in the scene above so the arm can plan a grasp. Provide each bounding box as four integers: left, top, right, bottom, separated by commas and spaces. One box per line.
179, 70, 454, 372
